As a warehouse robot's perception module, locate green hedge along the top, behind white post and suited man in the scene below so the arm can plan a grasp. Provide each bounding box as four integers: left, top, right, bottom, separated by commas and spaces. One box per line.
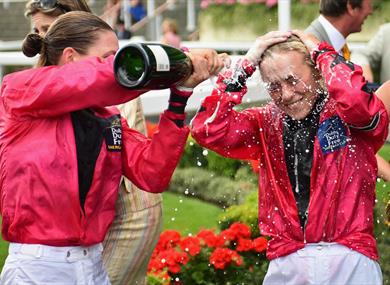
198, 0, 390, 41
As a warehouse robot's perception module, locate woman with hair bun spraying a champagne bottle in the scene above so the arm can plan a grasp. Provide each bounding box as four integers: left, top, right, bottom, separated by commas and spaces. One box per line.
0, 12, 216, 285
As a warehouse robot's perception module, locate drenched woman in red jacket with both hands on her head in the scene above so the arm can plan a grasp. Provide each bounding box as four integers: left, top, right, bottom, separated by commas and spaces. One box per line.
191, 31, 388, 285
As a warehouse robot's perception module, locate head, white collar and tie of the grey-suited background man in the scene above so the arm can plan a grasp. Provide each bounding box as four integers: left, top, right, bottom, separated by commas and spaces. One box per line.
305, 0, 372, 60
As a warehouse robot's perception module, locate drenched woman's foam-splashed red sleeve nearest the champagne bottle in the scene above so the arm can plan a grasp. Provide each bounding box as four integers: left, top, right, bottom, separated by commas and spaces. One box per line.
191, 58, 260, 159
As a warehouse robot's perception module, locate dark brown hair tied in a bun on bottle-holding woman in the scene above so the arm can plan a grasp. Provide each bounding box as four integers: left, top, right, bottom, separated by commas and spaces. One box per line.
22, 12, 114, 66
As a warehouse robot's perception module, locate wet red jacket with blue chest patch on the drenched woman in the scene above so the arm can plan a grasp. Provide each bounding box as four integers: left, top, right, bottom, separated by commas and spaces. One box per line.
191, 44, 388, 260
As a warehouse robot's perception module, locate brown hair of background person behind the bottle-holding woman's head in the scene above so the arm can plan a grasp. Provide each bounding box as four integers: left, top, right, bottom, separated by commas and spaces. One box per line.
24, 0, 92, 17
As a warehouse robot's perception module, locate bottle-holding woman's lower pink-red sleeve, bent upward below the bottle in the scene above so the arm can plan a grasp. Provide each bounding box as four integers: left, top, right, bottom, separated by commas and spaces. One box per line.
122, 111, 189, 193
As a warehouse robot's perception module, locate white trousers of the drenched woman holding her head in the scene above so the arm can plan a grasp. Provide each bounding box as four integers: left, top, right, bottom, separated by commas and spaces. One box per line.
263, 243, 383, 285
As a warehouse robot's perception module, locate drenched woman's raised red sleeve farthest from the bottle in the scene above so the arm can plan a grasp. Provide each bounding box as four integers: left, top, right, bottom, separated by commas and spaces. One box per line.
314, 43, 389, 150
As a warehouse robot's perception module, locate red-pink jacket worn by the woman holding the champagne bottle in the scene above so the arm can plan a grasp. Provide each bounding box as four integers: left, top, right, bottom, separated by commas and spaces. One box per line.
0, 57, 189, 246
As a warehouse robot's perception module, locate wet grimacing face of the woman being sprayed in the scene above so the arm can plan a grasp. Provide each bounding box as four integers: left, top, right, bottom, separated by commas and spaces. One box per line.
260, 51, 321, 120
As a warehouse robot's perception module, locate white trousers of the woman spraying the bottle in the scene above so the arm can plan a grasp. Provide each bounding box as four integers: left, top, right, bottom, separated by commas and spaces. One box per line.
0, 243, 110, 285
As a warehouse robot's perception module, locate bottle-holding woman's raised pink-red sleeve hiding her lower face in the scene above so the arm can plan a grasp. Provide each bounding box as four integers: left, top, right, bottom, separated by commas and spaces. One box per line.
1, 56, 143, 117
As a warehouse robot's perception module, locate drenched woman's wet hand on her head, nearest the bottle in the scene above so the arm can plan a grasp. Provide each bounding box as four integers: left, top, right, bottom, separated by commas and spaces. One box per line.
244, 31, 291, 65
